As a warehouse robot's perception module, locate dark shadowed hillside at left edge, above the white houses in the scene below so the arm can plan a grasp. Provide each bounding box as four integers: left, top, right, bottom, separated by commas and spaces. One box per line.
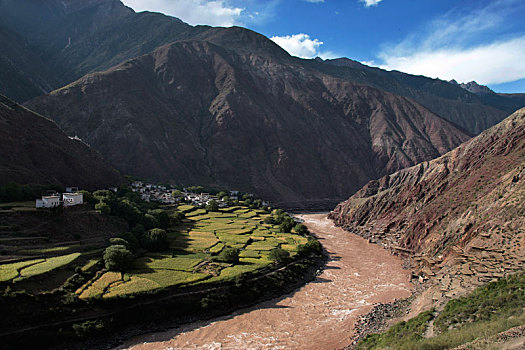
0, 95, 123, 189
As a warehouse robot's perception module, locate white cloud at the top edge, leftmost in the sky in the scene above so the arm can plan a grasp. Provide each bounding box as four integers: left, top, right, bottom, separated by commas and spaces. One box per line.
123, 0, 244, 27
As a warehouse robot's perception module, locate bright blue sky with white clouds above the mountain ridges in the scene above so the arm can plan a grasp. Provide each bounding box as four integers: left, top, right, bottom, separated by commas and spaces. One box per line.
123, 0, 525, 92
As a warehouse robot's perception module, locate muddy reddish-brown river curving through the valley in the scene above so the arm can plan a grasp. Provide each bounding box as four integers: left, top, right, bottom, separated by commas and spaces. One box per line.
119, 214, 411, 349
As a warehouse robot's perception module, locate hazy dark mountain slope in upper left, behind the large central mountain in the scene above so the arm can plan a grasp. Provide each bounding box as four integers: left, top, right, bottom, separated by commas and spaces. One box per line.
0, 0, 206, 102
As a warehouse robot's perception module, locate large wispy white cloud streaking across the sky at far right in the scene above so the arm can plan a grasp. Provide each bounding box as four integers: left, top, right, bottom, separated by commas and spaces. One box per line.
379, 0, 525, 84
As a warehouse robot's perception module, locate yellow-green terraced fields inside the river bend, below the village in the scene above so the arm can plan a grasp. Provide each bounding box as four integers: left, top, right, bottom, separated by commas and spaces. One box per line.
76, 205, 308, 299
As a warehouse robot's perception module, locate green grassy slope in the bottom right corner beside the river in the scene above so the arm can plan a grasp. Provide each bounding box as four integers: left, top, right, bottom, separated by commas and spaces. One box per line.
357, 273, 525, 350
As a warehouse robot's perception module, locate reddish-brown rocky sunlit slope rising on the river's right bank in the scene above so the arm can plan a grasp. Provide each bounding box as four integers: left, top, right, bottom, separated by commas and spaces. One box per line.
330, 109, 525, 299
